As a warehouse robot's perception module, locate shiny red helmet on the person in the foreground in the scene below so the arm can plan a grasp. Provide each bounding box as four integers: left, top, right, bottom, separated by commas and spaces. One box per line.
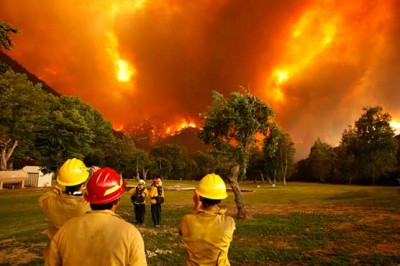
84, 167, 125, 204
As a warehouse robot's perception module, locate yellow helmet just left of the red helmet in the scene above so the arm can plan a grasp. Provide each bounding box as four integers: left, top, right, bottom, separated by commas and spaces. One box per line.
57, 158, 89, 186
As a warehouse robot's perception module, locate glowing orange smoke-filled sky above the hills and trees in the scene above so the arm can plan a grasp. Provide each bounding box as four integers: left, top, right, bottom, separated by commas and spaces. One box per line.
0, 0, 400, 157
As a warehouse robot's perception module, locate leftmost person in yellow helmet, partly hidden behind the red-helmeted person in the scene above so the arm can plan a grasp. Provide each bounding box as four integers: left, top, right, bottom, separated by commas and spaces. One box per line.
39, 158, 94, 264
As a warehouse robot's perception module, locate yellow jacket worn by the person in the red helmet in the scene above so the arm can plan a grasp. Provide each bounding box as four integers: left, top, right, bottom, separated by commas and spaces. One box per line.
49, 210, 147, 266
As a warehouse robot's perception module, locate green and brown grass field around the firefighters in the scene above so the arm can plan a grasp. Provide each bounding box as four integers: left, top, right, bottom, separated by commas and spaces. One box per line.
0, 181, 400, 266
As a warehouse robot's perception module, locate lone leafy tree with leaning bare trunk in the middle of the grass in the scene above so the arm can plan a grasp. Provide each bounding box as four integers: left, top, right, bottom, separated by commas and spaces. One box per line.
199, 88, 274, 219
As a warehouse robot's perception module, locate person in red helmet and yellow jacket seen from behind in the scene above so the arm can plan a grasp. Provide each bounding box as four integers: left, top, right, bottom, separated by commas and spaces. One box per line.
49, 167, 147, 266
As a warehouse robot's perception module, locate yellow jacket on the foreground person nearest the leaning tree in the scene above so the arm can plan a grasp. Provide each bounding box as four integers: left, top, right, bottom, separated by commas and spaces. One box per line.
179, 209, 236, 266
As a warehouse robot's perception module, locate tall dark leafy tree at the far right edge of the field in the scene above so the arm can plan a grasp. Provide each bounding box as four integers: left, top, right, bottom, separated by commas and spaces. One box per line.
341, 106, 398, 184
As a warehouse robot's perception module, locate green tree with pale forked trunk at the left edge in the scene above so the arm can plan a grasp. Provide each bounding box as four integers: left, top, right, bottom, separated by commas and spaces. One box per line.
0, 70, 53, 170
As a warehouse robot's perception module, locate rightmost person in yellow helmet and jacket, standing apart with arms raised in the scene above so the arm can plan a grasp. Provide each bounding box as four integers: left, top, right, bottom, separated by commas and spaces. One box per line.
179, 174, 236, 266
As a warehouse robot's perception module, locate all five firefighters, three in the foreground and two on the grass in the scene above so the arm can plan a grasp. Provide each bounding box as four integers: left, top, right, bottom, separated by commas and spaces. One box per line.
39, 158, 236, 266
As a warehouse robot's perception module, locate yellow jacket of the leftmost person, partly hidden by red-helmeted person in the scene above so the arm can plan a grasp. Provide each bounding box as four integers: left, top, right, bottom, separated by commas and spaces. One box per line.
39, 187, 91, 241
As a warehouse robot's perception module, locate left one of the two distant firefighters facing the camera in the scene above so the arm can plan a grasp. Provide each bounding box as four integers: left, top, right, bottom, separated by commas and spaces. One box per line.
129, 179, 149, 226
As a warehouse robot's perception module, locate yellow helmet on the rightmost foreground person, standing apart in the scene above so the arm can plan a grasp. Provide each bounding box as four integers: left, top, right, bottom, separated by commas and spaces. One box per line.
196, 174, 228, 200
